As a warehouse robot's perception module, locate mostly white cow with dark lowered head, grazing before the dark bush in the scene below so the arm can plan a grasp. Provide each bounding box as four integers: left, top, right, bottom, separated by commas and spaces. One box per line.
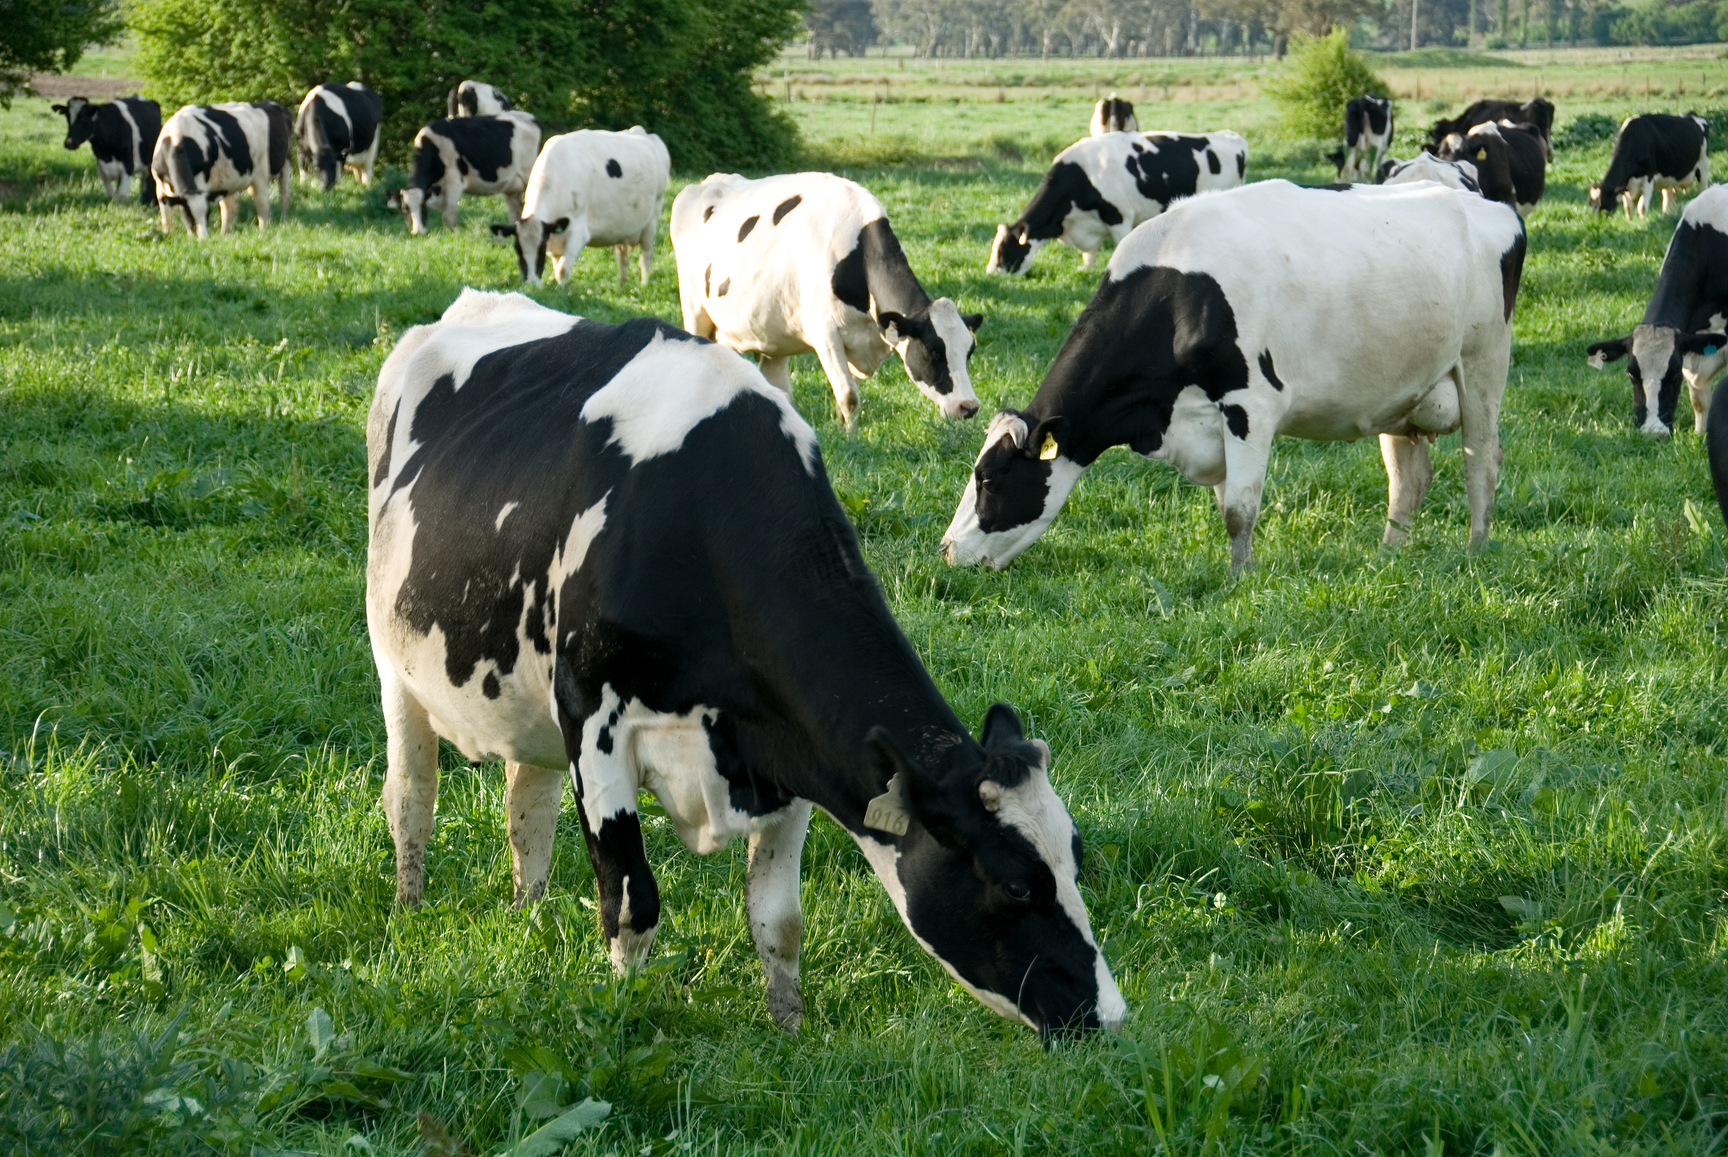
492, 124, 672, 285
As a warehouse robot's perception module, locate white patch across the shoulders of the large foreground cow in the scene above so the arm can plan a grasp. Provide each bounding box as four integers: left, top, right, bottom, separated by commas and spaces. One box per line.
582, 333, 817, 473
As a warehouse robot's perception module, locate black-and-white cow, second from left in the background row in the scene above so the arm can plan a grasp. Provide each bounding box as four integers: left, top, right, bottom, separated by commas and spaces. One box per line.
150, 100, 294, 237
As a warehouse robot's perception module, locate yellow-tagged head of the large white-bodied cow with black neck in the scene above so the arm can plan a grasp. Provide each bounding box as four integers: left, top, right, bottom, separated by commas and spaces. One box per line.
942, 409, 1085, 570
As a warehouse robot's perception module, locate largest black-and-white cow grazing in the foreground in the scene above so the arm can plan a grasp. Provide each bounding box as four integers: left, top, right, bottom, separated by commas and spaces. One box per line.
366, 290, 1125, 1033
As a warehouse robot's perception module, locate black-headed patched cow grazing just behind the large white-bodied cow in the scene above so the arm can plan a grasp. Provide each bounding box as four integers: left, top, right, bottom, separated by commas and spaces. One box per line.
985, 130, 1248, 275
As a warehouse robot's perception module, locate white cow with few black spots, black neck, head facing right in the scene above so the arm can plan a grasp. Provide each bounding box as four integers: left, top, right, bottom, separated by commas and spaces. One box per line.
672, 173, 983, 427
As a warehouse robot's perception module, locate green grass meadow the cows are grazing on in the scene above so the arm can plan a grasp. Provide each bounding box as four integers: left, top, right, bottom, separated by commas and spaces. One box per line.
0, 45, 1728, 1157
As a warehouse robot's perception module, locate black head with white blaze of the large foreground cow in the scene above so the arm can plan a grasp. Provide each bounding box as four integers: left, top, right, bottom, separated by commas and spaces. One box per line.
859, 703, 1127, 1038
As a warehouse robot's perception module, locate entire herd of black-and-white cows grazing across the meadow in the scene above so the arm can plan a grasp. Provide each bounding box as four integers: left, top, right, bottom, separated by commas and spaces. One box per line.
47, 81, 1728, 1033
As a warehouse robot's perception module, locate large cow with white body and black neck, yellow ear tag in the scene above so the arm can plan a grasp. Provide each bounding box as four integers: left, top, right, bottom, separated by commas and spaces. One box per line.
942, 181, 1526, 570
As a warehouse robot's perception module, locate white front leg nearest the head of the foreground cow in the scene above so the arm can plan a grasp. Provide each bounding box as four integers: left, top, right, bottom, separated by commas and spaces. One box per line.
745, 800, 810, 1033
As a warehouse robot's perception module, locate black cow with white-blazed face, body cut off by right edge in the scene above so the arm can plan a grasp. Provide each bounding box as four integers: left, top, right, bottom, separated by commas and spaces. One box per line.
1586, 185, 1728, 437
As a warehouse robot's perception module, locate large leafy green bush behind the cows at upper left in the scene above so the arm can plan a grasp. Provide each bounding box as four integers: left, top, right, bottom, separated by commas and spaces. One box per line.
128, 0, 804, 173
